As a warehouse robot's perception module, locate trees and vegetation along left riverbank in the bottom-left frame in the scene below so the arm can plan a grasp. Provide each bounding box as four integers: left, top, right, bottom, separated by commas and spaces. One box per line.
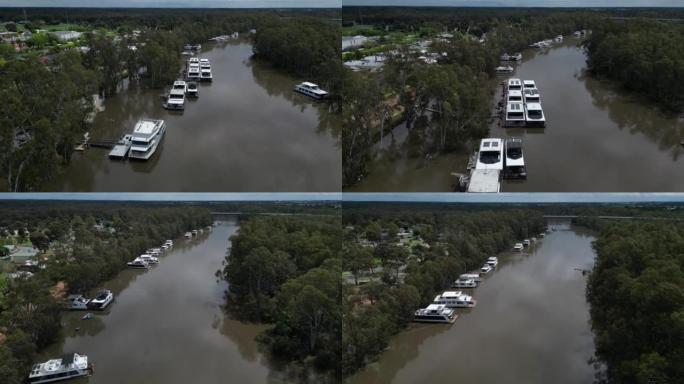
0, 204, 212, 383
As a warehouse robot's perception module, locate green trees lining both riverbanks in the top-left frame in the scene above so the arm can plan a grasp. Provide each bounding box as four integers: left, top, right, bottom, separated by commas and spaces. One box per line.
0, 9, 344, 192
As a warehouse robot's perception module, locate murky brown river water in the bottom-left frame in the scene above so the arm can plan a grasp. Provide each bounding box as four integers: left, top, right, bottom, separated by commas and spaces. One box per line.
42, 221, 278, 384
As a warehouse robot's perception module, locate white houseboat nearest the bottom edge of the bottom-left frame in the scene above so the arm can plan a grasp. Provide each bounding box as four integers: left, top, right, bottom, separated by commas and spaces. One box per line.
28, 353, 93, 384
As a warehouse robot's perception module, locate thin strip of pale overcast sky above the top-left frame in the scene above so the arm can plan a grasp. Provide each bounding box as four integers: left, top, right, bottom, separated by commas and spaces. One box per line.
0, 0, 340, 8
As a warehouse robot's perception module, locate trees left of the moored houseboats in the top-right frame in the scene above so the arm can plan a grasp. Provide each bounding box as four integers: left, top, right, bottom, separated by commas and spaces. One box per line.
340, 8, 601, 186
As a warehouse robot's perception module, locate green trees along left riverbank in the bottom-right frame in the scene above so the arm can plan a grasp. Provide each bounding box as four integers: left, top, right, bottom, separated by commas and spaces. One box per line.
342, 205, 545, 376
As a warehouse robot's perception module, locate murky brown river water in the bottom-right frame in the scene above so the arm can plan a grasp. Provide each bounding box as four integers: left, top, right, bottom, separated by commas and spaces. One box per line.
349, 224, 595, 384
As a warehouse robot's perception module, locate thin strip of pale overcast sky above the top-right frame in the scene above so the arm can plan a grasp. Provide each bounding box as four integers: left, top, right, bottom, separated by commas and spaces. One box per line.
342, 0, 684, 7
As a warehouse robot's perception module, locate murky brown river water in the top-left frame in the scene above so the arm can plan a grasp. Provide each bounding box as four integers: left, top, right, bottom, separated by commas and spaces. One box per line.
45, 41, 342, 192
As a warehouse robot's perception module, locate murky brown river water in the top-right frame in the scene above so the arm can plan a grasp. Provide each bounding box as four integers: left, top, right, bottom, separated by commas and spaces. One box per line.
349, 38, 684, 192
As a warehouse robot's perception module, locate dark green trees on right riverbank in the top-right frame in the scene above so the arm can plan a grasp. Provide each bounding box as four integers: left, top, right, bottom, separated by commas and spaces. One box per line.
585, 19, 684, 111
